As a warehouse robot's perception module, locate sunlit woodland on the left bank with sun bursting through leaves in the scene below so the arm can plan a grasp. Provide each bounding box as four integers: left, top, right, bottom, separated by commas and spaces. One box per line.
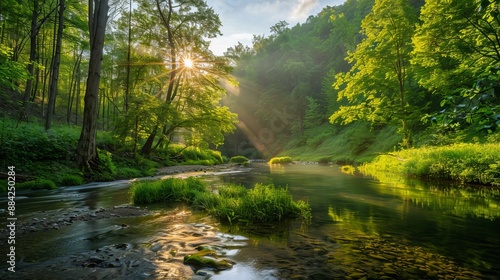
0, 0, 236, 177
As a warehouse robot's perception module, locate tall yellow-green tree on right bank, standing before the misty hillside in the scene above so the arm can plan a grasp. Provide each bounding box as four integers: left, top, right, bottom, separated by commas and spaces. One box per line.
330, 0, 416, 147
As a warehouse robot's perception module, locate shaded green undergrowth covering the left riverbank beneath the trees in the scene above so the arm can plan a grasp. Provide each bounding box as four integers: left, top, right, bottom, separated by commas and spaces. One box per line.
0, 118, 223, 191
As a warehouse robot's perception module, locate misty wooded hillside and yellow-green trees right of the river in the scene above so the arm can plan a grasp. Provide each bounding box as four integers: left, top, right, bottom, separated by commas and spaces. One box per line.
222, 0, 500, 167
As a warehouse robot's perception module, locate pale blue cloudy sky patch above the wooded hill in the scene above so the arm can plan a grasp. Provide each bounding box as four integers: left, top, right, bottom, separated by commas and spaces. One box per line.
206, 0, 345, 55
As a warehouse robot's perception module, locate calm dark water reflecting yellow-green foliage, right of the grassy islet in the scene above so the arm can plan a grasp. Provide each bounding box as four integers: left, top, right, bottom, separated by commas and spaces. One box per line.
214, 164, 500, 279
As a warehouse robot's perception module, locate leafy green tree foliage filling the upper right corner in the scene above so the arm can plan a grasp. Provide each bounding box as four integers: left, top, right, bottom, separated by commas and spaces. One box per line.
412, 0, 500, 131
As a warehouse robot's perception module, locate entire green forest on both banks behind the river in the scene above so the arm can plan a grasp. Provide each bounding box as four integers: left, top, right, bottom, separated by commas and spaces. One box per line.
0, 0, 500, 187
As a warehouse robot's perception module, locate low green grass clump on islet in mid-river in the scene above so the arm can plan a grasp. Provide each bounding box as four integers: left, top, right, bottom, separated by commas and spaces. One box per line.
130, 177, 311, 224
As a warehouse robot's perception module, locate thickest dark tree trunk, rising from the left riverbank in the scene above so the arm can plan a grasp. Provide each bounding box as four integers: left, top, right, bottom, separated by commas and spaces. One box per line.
76, 0, 109, 173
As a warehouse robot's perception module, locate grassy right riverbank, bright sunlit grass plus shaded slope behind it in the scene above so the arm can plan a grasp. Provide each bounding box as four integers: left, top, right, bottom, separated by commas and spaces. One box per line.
279, 123, 500, 186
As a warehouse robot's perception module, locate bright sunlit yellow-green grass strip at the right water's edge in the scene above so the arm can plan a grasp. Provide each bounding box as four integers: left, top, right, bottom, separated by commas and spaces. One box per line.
360, 143, 500, 186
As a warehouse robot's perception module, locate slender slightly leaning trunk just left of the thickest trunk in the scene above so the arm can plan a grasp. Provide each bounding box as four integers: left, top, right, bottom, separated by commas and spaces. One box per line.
45, 0, 66, 130
